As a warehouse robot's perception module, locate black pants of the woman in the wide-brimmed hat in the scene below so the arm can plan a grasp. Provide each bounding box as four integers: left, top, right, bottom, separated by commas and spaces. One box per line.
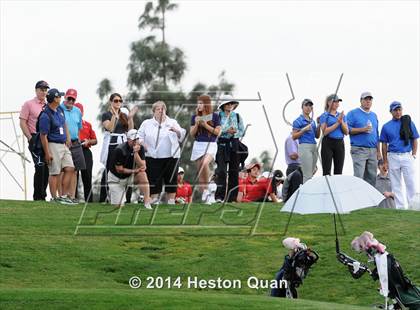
215, 138, 239, 202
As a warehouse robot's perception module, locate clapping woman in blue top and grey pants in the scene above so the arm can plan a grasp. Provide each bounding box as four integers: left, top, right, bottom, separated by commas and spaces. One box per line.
292, 99, 320, 183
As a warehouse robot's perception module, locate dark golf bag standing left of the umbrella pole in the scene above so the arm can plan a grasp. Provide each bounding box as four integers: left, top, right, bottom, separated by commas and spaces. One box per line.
270, 238, 319, 298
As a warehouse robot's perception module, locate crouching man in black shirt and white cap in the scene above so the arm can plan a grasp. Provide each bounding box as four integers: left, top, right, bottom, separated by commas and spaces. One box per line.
108, 129, 152, 209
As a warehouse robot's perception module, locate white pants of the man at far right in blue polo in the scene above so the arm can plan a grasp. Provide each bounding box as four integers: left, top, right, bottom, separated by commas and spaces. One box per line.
388, 152, 416, 209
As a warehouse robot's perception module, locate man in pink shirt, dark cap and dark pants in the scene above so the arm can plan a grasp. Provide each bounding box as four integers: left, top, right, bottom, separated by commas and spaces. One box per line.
19, 81, 50, 200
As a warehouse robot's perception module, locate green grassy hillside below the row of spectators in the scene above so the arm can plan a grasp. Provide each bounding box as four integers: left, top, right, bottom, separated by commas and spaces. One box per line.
0, 201, 420, 309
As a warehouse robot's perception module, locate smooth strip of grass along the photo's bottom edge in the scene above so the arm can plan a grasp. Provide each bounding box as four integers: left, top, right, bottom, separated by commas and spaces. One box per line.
0, 289, 369, 310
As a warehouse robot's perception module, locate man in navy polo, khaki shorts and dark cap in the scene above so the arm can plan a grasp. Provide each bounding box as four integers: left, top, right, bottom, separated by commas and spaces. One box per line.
39, 88, 74, 204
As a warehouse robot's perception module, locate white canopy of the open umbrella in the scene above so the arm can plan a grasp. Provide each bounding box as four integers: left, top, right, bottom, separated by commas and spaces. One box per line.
281, 175, 385, 214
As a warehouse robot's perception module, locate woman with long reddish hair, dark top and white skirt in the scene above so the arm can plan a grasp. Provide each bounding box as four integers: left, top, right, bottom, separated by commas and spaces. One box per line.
190, 95, 220, 202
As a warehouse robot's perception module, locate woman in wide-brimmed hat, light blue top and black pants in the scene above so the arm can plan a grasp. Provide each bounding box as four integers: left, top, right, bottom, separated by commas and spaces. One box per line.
215, 95, 244, 202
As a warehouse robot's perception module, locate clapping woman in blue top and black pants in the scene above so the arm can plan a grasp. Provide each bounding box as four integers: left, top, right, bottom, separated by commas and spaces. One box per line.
320, 94, 349, 175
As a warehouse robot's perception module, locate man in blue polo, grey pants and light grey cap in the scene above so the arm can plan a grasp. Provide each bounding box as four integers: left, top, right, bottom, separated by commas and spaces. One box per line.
347, 92, 381, 187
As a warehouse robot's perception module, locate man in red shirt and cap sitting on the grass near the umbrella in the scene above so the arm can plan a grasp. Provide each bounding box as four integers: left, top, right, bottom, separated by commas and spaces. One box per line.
237, 163, 283, 202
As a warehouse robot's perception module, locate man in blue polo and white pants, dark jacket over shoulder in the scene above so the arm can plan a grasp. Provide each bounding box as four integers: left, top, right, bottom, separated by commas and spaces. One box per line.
379, 101, 419, 209
